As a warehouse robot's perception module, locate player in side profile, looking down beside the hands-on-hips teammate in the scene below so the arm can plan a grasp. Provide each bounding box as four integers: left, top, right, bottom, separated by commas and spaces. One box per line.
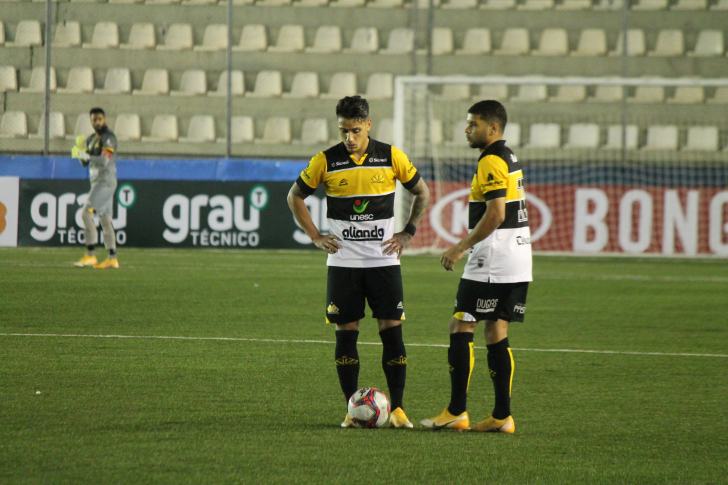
422, 101, 532, 433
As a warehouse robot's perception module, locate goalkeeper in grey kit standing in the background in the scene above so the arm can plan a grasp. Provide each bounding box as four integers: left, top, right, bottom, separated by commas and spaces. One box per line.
71, 108, 119, 269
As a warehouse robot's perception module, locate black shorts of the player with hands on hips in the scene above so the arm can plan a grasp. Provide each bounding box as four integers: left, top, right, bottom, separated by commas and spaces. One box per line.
326, 265, 404, 324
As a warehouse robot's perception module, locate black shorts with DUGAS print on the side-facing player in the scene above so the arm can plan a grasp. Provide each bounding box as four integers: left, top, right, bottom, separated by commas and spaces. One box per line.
453, 279, 528, 322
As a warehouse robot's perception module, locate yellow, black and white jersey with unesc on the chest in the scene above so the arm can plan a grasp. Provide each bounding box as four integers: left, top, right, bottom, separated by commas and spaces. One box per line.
296, 138, 420, 268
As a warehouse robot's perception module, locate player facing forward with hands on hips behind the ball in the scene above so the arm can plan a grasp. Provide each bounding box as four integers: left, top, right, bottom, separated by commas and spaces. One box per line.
288, 96, 429, 428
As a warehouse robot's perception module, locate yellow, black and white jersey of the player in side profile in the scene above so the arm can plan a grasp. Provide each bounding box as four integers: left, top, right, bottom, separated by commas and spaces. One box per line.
463, 140, 533, 283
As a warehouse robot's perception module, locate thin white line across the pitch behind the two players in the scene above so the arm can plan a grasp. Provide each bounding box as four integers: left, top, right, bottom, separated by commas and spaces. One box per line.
0, 333, 728, 358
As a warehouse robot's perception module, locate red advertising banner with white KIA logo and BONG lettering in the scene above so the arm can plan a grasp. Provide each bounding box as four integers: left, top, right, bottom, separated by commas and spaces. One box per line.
413, 182, 728, 256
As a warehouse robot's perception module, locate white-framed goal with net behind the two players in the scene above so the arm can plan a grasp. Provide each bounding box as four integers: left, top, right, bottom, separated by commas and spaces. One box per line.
393, 76, 728, 257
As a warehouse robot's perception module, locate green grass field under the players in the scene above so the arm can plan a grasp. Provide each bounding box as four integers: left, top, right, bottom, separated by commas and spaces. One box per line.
0, 249, 728, 484
